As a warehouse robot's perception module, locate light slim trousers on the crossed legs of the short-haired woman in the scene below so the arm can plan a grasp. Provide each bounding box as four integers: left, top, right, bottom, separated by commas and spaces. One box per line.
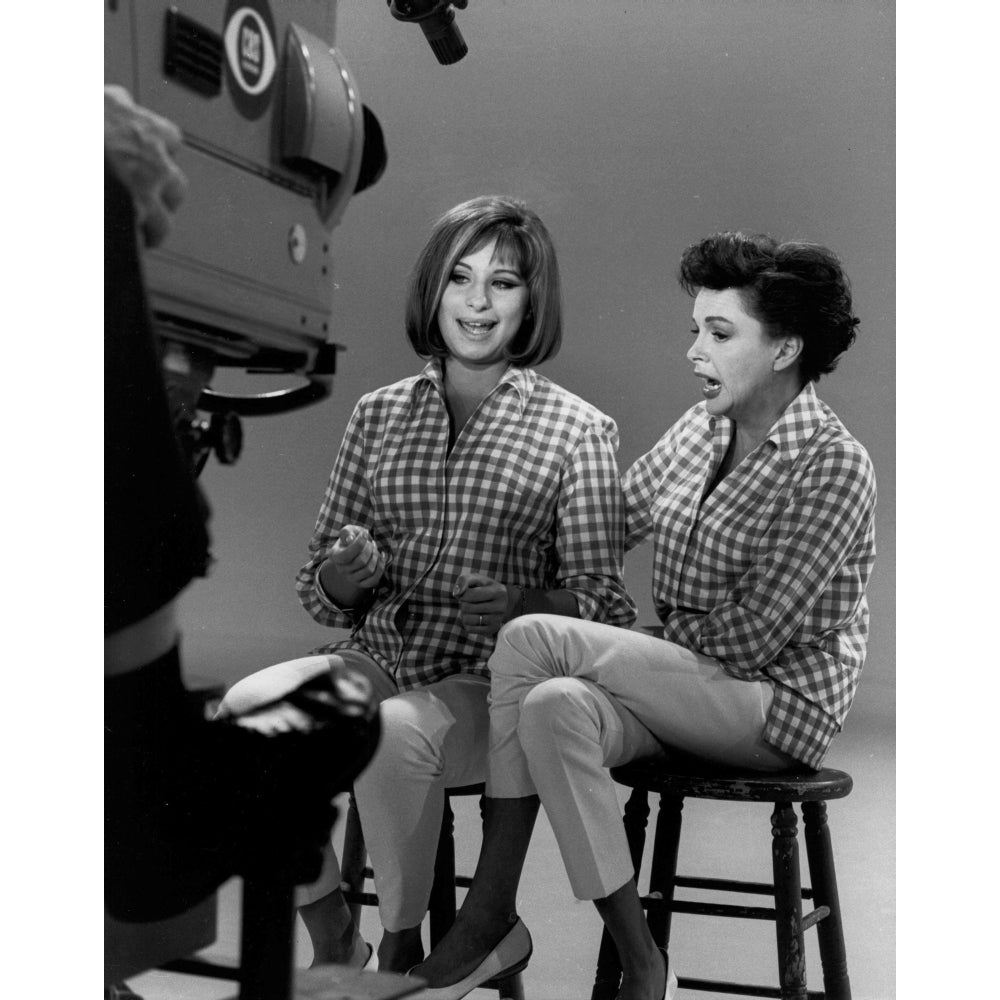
486, 615, 793, 899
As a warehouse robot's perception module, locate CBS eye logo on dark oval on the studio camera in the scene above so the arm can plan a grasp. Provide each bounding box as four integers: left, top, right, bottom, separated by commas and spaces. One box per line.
222, 0, 277, 119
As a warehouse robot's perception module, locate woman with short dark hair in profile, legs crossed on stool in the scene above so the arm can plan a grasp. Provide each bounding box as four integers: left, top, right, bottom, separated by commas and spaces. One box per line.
414, 233, 875, 1000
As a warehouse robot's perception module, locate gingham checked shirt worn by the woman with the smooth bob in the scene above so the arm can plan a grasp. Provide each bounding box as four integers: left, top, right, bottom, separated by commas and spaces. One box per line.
296, 361, 635, 690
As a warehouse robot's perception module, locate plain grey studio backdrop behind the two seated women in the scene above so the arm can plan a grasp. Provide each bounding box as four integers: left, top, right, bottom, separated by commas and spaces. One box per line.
182, 0, 895, 725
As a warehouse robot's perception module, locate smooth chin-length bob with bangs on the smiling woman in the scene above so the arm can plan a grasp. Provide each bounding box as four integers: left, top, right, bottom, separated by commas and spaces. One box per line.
406, 195, 562, 368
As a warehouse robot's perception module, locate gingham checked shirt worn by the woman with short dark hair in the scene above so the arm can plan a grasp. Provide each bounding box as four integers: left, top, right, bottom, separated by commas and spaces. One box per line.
624, 382, 875, 767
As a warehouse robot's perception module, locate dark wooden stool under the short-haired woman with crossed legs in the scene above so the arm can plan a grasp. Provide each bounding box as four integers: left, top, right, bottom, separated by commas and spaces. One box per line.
591, 751, 853, 1000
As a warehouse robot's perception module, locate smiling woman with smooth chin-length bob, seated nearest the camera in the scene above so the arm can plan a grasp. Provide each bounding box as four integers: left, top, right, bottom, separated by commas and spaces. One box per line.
216, 197, 635, 971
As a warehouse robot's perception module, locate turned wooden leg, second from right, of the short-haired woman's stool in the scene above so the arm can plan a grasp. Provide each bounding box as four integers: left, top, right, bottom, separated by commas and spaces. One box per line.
771, 802, 806, 1000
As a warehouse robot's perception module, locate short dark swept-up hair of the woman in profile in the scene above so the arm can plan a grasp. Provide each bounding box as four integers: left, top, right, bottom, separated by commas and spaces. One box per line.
678, 232, 860, 382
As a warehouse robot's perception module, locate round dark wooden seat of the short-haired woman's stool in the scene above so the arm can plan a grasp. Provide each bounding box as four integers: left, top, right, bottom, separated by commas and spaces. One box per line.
611, 751, 854, 802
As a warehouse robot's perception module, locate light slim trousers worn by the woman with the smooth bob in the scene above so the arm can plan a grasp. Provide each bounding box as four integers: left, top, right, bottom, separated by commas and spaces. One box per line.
220, 649, 490, 931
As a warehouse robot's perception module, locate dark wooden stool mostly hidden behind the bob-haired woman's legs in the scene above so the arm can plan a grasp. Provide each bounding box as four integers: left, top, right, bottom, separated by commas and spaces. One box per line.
341, 783, 524, 1000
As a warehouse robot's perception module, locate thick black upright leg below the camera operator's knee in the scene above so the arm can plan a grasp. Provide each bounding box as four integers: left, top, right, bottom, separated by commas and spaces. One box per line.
240, 871, 295, 1000
